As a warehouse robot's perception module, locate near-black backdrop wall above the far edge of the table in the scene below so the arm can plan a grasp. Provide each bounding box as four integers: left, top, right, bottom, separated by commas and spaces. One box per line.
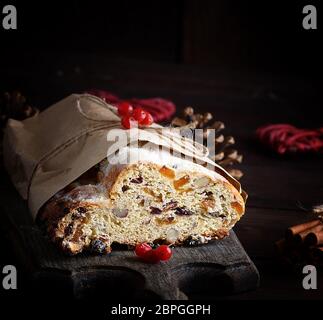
0, 0, 322, 76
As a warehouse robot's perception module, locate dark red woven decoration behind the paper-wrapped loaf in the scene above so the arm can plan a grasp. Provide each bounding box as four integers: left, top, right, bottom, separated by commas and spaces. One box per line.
87, 89, 176, 122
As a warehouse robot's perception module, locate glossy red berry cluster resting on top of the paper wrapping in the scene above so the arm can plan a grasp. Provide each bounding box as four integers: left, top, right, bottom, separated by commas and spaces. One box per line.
118, 101, 154, 129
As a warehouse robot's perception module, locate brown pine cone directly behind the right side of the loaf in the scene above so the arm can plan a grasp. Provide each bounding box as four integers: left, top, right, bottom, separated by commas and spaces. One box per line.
171, 107, 243, 179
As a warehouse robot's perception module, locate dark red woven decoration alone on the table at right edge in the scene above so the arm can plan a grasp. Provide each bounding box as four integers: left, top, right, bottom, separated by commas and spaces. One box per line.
256, 124, 323, 154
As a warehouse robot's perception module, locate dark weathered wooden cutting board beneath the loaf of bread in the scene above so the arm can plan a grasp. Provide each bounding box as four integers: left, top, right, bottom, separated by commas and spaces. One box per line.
0, 170, 259, 300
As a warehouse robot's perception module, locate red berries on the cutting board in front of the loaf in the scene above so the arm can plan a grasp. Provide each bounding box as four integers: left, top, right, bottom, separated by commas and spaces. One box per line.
135, 243, 172, 263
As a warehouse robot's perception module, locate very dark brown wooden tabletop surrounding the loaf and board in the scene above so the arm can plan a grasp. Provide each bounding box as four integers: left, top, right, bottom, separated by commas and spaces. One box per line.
0, 53, 323, 299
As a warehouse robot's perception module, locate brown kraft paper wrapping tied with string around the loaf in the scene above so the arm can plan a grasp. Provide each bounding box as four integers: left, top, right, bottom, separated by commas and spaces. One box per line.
4, 94, 245, 219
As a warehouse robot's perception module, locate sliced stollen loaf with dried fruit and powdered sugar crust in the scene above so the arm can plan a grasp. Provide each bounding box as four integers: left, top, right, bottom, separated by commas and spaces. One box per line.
39, 147, 245, 254
